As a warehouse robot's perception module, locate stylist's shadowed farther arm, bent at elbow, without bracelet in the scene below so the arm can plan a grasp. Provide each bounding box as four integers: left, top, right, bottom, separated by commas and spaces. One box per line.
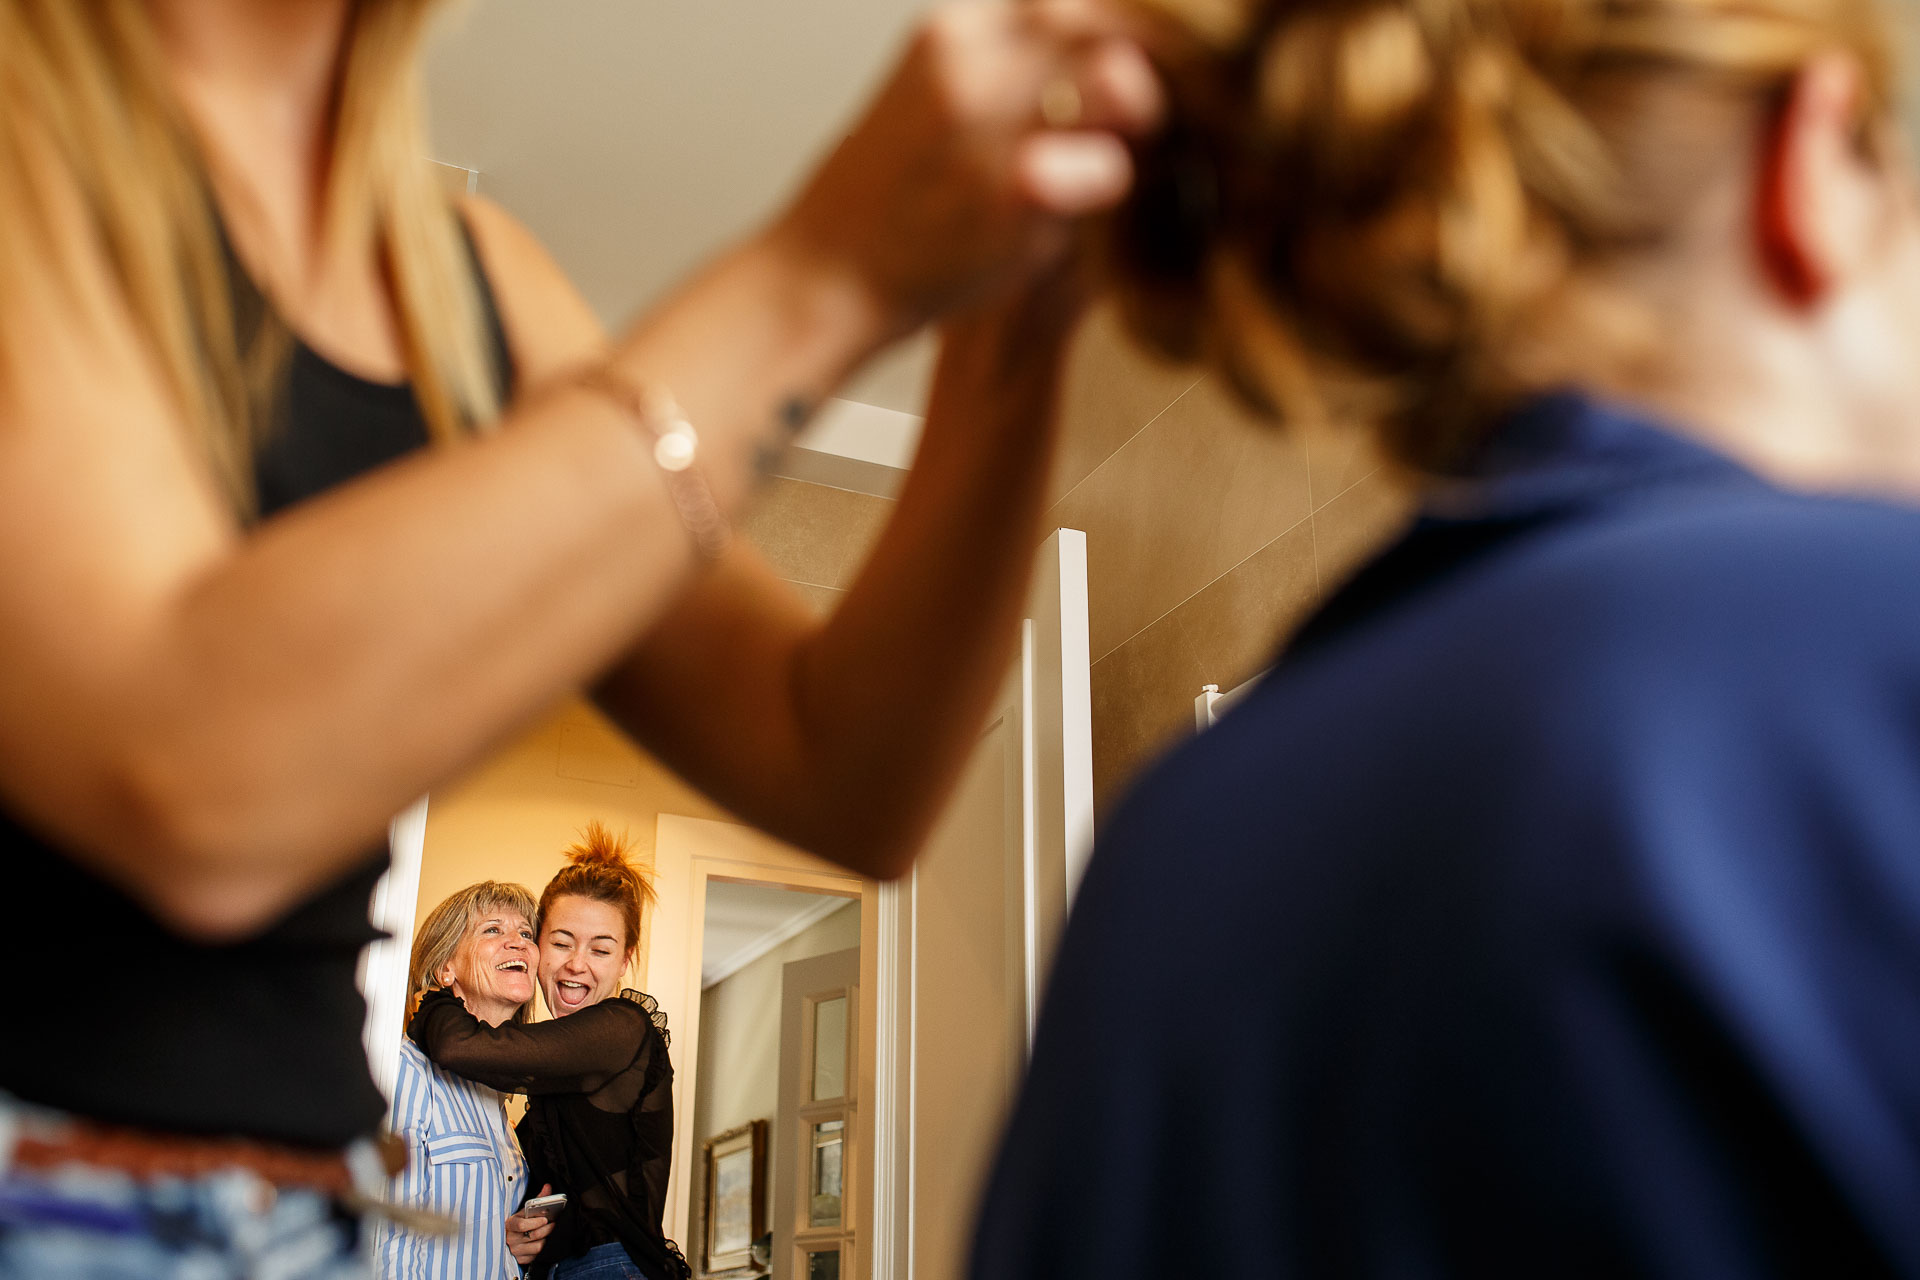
599, 280, 1077, 877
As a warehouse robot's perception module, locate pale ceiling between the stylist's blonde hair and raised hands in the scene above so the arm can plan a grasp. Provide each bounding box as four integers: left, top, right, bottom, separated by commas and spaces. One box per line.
428, 0, 929, 415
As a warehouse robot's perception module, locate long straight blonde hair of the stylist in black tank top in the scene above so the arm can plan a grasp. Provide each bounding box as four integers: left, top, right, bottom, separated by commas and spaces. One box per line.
0, 0, 499, 512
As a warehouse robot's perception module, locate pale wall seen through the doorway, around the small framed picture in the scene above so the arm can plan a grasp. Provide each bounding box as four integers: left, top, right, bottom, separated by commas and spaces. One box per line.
682, 902, 860, 1267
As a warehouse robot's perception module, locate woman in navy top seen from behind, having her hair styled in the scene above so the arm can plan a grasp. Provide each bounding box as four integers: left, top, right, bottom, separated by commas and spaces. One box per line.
973, 0, 1920, 1280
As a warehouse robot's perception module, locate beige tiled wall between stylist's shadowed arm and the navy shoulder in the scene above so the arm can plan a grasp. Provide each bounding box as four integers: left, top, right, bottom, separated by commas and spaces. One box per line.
1048, 305, 1407, 804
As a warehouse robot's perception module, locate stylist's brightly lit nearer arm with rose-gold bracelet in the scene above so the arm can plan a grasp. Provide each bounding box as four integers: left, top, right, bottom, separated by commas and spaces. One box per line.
0, 188, 876, 935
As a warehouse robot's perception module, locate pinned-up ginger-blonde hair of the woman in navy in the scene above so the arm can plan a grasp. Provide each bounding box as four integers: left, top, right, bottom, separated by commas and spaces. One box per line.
1114, 0, 1893, 472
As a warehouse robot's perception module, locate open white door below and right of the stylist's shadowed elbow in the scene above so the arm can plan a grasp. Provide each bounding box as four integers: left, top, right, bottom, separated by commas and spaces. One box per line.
870, 530, 1092, 1280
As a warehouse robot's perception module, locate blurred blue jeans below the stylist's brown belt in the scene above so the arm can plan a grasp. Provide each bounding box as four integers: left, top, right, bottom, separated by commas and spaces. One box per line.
0, 1094, 371, 1280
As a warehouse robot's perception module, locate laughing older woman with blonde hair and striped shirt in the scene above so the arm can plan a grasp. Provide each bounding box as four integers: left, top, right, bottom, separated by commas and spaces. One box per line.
372, 881, 540, 1280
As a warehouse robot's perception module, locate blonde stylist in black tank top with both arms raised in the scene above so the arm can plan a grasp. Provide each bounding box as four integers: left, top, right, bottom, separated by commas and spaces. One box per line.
0, 0, 1158, 1280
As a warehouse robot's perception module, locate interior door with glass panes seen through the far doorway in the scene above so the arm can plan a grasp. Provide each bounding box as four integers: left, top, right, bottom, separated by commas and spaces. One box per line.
774, 948, 862, 1280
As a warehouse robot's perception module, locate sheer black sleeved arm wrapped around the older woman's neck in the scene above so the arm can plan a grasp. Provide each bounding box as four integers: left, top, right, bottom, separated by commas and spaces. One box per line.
407, 990, 653, 1094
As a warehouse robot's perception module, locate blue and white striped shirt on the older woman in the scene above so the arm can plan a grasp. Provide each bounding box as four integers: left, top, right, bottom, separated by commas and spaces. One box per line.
372, 1038, 526, 1280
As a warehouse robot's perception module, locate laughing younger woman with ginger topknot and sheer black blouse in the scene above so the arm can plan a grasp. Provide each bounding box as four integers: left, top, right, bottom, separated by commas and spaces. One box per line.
411, 821, 687, 1280
